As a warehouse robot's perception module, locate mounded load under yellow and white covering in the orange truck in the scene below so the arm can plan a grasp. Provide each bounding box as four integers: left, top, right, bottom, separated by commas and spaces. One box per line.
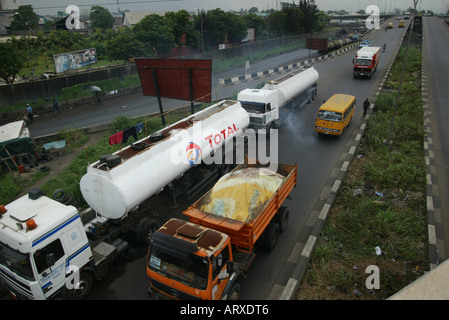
200, 168, 284, 222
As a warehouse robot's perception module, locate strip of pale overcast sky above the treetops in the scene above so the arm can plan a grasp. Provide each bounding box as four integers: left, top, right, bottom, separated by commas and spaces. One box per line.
22, 0, 449, 15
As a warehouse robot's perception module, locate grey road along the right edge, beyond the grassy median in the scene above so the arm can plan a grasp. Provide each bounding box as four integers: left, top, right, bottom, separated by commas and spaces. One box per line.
423, 17, 449, 262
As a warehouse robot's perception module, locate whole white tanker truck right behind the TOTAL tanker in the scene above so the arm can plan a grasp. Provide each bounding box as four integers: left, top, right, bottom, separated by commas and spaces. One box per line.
237, 67, 319, 131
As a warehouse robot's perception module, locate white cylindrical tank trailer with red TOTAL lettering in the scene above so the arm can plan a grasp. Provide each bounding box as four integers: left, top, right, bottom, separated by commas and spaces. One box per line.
80, 101, 249, 219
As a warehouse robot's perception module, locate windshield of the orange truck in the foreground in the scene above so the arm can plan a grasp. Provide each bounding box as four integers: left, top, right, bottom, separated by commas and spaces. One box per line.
149, 248, 209, 290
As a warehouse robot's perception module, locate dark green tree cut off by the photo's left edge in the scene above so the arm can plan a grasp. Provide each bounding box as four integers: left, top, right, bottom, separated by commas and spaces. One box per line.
0, 42, 25, 84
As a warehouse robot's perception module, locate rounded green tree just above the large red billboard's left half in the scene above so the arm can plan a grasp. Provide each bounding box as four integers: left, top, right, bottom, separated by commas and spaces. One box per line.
133, 14, 176, 58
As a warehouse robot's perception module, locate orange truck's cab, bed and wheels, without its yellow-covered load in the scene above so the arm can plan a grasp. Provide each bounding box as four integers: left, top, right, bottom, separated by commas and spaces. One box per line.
147, 163, 298, 300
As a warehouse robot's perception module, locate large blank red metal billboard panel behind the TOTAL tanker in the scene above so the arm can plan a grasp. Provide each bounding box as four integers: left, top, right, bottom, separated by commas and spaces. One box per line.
135, 58, 212, 102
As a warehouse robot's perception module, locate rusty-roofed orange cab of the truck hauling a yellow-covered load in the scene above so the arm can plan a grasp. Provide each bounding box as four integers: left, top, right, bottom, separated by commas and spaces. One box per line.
147, 219, 239, 300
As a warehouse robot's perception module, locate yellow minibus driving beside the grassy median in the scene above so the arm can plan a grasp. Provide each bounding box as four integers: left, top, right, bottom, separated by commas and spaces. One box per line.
315, 93, 356, 136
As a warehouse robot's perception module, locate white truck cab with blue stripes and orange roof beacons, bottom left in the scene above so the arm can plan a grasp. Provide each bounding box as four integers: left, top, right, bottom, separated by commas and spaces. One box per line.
0, 189, 92, 299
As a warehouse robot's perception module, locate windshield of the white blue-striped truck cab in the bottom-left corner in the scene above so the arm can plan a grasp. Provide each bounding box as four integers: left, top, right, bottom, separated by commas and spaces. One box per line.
0, 243, 34, 281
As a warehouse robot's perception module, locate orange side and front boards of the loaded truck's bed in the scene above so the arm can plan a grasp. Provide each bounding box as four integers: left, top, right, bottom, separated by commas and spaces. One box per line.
183, 163, 298, 252
